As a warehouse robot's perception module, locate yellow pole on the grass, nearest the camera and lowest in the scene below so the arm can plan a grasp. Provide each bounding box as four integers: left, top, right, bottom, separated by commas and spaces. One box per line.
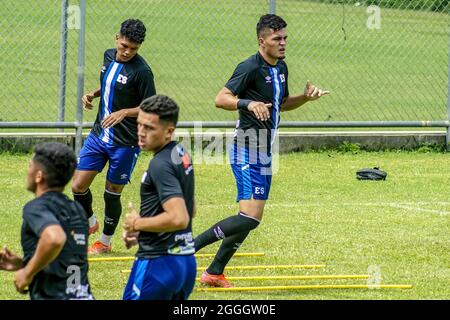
195, 284, 412, 292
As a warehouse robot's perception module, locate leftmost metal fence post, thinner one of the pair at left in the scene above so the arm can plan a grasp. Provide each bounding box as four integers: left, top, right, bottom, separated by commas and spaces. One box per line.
57, 0, 69, 132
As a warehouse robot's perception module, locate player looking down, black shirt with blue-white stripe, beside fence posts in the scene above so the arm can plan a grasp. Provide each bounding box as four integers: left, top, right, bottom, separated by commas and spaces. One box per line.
72, 19, 156, 254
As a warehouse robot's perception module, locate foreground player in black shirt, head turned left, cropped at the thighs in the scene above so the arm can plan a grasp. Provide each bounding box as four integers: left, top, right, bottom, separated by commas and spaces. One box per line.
123, 95, 197, 300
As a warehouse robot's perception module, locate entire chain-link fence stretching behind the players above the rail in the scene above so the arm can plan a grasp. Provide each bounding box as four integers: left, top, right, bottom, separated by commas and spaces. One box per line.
0, 0, 450, 125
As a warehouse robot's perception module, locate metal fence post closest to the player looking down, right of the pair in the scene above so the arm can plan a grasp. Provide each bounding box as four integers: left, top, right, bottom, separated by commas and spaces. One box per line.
75, 0, 86, 155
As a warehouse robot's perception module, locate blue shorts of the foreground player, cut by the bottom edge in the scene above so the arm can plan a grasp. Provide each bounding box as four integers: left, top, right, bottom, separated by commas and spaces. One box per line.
123, 255, 197, 300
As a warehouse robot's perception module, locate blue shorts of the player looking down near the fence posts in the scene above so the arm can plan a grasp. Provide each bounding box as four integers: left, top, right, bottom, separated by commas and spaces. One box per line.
77, 133, 141, 185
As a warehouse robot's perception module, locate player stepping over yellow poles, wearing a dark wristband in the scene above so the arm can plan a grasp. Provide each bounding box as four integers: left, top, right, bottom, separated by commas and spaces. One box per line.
194, 14, 329, 287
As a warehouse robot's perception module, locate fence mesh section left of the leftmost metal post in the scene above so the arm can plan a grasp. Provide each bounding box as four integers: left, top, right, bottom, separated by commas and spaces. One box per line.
0, 0, 61, 121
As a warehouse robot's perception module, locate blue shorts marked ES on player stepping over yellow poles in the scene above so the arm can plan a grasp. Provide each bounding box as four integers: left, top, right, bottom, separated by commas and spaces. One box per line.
229, 144, 272, 202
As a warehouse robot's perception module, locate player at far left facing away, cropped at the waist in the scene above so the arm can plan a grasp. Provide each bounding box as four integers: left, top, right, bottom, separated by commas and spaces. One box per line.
0, 142, 93, 300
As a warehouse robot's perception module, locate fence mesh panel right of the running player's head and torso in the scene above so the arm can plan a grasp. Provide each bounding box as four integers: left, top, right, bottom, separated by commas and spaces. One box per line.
277, 0, 449, 121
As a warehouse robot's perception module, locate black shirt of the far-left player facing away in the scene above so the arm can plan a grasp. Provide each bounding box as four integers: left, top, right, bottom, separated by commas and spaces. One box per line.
21, 192, 91, 300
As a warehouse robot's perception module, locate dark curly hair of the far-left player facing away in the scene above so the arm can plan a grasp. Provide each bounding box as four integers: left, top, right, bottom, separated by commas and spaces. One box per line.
33, 142, 77, 188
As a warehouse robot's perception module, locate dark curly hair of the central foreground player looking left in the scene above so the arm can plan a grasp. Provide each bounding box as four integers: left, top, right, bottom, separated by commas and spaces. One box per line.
140, 94, 180, 125
